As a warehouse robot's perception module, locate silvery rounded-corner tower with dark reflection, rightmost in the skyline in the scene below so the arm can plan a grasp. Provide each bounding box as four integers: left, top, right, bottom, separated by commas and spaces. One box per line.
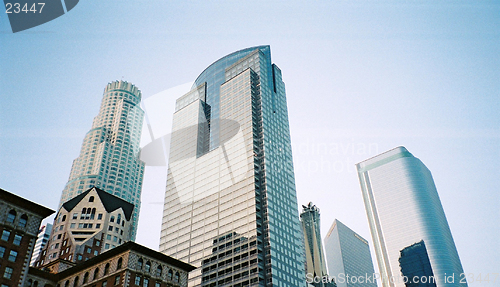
356, 147, 467, 287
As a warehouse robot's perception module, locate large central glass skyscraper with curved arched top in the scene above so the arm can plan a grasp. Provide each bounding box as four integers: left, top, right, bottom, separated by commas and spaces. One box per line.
160, 46, 305, 286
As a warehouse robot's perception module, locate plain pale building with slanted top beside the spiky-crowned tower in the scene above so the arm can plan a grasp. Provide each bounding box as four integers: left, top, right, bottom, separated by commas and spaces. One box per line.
325, 219, 377, 287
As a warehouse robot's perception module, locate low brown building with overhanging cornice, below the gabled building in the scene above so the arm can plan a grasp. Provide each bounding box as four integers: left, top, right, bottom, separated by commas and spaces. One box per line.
26, 241, 196, 287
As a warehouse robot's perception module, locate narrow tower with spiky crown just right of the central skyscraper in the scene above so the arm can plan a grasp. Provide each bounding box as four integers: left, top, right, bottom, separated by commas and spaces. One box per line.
300, 202, 328, 278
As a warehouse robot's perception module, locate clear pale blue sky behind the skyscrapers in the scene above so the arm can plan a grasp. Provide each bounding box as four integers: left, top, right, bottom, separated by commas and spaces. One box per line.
0, 0, 500, 286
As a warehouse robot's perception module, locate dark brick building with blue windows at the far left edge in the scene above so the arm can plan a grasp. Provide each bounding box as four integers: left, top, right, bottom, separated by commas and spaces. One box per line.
0, 189, 54, 287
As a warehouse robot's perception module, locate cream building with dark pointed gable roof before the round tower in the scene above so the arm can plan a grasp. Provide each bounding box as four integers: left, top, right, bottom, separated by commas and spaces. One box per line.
34, 187, 134, 269
